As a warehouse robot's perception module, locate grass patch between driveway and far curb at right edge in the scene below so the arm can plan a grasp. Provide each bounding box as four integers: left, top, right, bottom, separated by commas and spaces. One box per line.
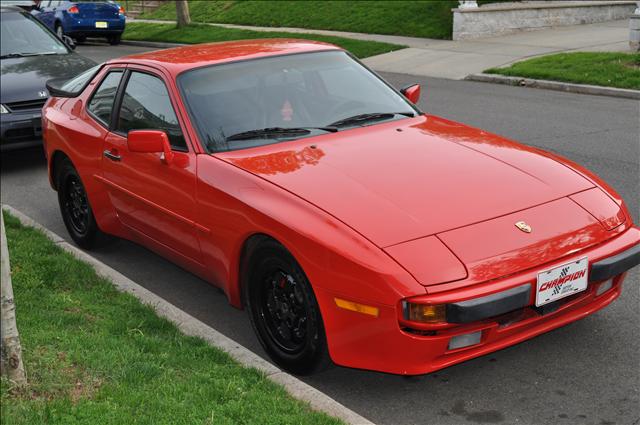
485, 52, 640, 90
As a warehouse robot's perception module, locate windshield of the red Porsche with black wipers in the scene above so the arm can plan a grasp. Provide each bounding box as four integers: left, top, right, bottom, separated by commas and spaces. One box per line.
178, 51, 417, 152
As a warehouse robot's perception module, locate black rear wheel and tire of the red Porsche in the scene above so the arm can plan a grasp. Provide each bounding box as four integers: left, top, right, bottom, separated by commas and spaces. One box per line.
56, 159, 106, 249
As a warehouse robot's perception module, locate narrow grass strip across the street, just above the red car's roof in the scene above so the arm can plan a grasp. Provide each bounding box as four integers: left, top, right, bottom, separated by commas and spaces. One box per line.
123, 23, 406, 58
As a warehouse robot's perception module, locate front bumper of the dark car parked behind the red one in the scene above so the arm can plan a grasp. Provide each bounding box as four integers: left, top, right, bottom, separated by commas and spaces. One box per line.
0, 110, 42, 152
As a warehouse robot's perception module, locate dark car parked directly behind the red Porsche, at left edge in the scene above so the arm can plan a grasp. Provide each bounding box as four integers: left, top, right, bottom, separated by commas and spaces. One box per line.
0, 5, 95, 151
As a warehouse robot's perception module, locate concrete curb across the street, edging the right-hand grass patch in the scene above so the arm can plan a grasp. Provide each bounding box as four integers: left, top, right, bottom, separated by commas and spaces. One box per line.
465, 73, 640, 99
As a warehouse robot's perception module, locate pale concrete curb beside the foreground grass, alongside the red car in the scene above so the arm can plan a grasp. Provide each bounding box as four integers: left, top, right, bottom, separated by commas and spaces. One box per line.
2, 205, 374, 425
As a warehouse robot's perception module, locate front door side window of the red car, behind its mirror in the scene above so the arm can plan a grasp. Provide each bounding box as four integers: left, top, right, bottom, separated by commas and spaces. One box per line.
116, 72, 187, 150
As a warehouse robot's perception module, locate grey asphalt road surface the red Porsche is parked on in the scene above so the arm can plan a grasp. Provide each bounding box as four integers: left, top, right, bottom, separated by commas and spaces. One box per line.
0, 45, 640, 425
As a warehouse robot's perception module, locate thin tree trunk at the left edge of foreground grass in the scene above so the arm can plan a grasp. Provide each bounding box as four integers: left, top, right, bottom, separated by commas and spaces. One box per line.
0, 210, 27, 387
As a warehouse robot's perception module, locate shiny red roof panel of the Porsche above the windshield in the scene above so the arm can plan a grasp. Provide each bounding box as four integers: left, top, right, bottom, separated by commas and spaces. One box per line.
114, 38, 341, 75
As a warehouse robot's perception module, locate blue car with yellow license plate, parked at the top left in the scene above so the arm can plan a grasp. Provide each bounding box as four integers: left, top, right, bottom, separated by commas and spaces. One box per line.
32, 0, 126, 45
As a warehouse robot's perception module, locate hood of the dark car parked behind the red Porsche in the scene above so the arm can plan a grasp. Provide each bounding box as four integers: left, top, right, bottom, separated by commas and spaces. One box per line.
0, 53, 95, 103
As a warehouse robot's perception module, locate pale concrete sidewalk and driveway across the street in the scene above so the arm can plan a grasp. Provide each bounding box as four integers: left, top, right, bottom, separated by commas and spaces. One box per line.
130, 19, 629, 80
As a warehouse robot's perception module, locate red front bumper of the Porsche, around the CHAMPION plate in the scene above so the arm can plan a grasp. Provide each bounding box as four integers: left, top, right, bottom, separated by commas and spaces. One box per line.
317, 227, 640, 375
